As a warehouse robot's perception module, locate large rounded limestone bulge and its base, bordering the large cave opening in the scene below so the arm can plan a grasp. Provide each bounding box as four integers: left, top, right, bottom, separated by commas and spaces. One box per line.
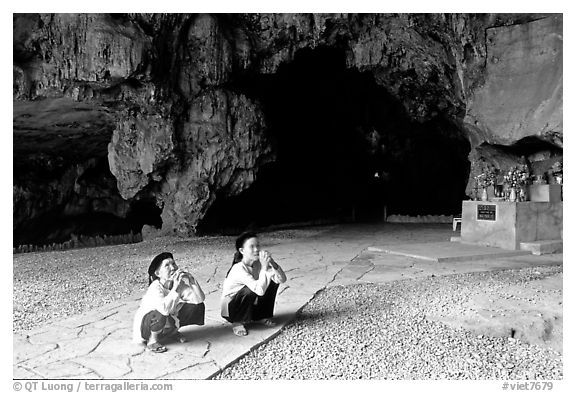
159, 90, 273, 234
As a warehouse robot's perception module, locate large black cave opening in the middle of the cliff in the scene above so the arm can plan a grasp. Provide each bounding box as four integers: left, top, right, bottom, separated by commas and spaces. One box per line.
198, 47, 470, 233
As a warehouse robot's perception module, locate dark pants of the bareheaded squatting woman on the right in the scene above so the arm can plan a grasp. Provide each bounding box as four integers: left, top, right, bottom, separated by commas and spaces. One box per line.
224, 281, 279, 323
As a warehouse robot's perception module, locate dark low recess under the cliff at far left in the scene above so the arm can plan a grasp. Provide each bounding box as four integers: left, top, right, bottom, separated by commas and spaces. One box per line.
13, 153, 162, 247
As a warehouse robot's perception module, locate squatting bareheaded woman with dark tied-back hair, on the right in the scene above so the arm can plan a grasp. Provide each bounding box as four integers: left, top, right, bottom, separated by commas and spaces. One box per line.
221, 232, 286, 336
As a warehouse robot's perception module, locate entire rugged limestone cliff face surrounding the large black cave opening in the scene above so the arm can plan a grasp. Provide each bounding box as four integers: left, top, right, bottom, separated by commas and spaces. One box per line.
13, 14, 563, 239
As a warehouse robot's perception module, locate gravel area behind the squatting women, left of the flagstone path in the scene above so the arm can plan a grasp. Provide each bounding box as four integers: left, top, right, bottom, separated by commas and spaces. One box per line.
13, 227, 332, 332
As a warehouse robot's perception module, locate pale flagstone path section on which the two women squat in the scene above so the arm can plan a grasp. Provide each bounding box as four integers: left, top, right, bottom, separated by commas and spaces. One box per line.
13, 231, 368, 379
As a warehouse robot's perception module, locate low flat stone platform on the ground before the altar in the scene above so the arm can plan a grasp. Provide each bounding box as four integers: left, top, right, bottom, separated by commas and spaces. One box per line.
368, 242, 530, 262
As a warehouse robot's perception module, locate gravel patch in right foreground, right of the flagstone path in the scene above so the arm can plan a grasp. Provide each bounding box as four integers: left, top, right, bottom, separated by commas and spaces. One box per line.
215, 266, 563, 380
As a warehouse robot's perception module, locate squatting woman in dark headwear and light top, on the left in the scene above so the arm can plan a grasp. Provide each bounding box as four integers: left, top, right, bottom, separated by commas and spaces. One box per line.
133, 252, 205, 353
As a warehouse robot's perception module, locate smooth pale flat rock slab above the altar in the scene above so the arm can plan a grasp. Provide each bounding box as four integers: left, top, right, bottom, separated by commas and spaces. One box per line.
464, 16, 563, 147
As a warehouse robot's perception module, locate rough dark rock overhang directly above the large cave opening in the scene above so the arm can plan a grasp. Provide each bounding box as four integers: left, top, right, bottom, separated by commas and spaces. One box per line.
245, 14, 469, 121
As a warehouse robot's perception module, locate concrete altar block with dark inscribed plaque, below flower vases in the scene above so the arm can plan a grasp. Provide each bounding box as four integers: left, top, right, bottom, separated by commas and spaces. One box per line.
461, 201, 562, 250
